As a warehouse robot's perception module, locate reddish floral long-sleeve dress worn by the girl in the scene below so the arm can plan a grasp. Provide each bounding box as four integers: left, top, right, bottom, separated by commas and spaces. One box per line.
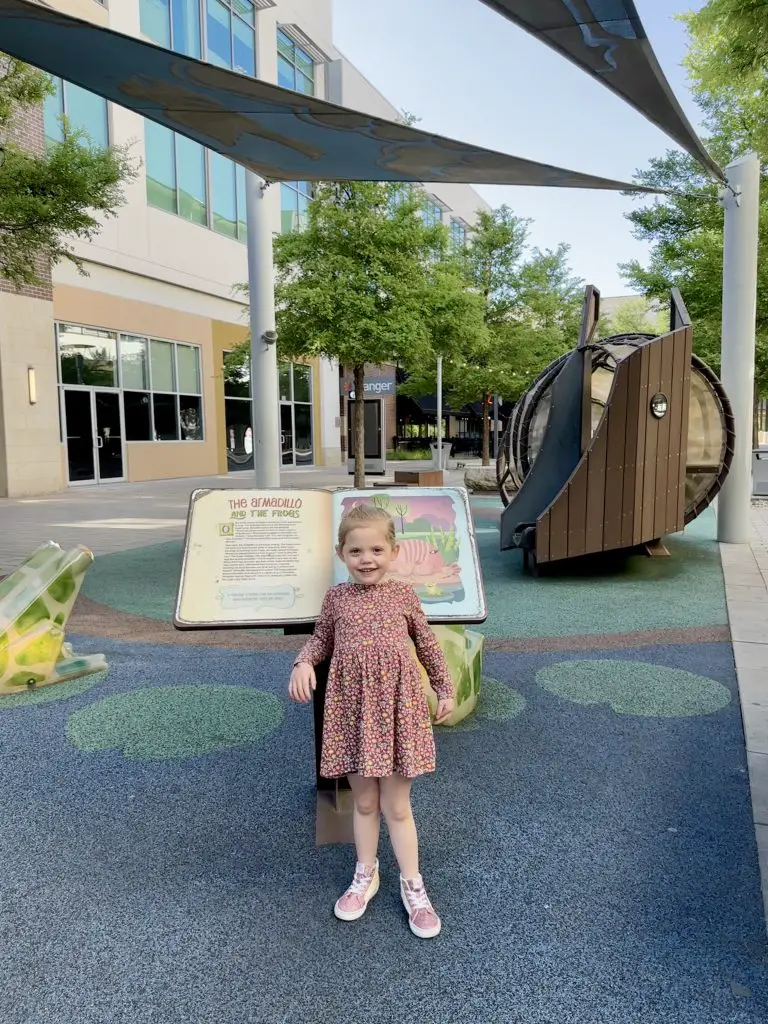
294, 580, 454, 778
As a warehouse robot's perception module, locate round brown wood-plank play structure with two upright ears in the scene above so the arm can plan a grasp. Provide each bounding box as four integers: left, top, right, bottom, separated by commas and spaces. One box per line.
497, 286, 734, 572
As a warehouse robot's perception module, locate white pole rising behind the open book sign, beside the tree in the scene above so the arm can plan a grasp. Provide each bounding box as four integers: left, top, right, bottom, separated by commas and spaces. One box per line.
246, 171, 282, 487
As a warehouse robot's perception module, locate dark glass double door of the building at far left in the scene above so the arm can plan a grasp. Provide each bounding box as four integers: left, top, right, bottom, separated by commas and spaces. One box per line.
65, 388, 124, 483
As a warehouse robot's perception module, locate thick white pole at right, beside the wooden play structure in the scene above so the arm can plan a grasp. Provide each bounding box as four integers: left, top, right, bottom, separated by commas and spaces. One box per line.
718, 153, 760, 544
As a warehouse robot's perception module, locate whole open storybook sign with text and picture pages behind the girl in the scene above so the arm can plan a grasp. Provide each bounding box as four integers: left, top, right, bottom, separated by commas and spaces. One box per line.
173, 487, 487, 630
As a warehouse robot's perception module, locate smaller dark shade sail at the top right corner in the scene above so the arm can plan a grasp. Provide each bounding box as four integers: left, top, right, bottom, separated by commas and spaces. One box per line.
482, 0, 725, 181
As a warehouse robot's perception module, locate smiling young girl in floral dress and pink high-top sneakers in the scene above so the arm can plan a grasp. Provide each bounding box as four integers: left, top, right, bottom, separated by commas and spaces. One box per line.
289, 505, 454, 939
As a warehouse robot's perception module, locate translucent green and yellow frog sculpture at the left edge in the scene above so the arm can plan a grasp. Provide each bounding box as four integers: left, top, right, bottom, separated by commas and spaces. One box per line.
0, 541, 108, 696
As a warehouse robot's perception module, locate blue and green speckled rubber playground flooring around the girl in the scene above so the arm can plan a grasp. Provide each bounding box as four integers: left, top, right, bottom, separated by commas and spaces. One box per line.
0, 500, 768, 1024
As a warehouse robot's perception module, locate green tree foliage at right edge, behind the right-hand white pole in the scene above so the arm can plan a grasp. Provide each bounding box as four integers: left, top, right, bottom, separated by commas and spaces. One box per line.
621, 0, 768, 394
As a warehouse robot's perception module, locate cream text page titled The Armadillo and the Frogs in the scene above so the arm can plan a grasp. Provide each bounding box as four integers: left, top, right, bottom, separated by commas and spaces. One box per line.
173, 487, 334, 629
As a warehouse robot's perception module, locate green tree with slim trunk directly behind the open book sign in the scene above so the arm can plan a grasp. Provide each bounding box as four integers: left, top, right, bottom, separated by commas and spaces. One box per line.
274, 182, 444, 487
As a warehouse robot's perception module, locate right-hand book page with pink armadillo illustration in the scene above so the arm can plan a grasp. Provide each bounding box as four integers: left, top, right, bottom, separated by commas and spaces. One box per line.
333, 486, 487, 623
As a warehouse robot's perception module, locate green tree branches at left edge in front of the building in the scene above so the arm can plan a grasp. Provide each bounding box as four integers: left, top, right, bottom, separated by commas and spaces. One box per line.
0, 54, 135, 287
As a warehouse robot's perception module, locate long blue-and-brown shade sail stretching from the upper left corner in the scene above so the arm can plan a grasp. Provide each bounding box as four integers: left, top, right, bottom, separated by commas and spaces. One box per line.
0, 0, 658, 191
